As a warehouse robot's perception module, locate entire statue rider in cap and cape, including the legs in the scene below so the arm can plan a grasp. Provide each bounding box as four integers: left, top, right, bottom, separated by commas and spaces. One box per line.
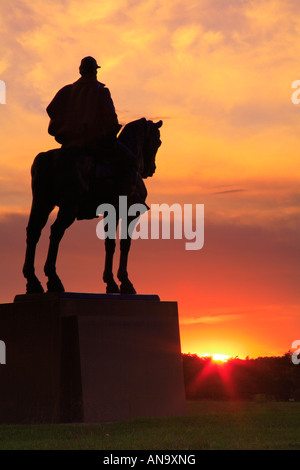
47, 56, 137, 210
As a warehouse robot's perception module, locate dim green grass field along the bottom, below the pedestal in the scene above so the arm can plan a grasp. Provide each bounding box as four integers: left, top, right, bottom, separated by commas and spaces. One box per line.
0, 401, 300, 450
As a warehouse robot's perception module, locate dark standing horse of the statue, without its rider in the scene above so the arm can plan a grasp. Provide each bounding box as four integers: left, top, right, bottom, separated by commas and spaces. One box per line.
23, 118, 163, 294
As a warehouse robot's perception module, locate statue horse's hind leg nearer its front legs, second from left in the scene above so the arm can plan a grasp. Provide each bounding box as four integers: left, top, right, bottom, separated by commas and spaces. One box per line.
44, 207, 76, 292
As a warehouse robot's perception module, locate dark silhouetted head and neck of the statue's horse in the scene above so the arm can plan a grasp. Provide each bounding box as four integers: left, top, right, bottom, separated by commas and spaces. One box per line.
119, 118, 163, 178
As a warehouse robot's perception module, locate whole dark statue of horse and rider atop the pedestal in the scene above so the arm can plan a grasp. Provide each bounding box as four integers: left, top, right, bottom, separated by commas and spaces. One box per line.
23, 57, 162, 294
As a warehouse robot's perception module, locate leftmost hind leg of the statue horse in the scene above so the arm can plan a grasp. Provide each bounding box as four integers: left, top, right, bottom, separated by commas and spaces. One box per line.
23, 198, 53, 294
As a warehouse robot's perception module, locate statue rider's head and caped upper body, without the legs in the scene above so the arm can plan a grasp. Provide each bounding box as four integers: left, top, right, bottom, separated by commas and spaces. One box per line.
47, 57, 122, 151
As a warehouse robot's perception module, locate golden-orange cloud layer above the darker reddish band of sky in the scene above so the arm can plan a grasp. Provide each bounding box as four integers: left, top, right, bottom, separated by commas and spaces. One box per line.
0, 0, 300, 235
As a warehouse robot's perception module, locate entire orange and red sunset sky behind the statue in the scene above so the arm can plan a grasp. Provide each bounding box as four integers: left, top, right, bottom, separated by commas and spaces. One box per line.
0, 0, 300, 358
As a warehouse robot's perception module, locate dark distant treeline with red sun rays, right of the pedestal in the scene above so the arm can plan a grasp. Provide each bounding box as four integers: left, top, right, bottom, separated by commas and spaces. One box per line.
182, 353, 300, 401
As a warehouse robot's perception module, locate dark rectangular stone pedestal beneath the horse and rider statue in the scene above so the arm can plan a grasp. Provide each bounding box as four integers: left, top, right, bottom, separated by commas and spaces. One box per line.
0, 293, 185, 424
